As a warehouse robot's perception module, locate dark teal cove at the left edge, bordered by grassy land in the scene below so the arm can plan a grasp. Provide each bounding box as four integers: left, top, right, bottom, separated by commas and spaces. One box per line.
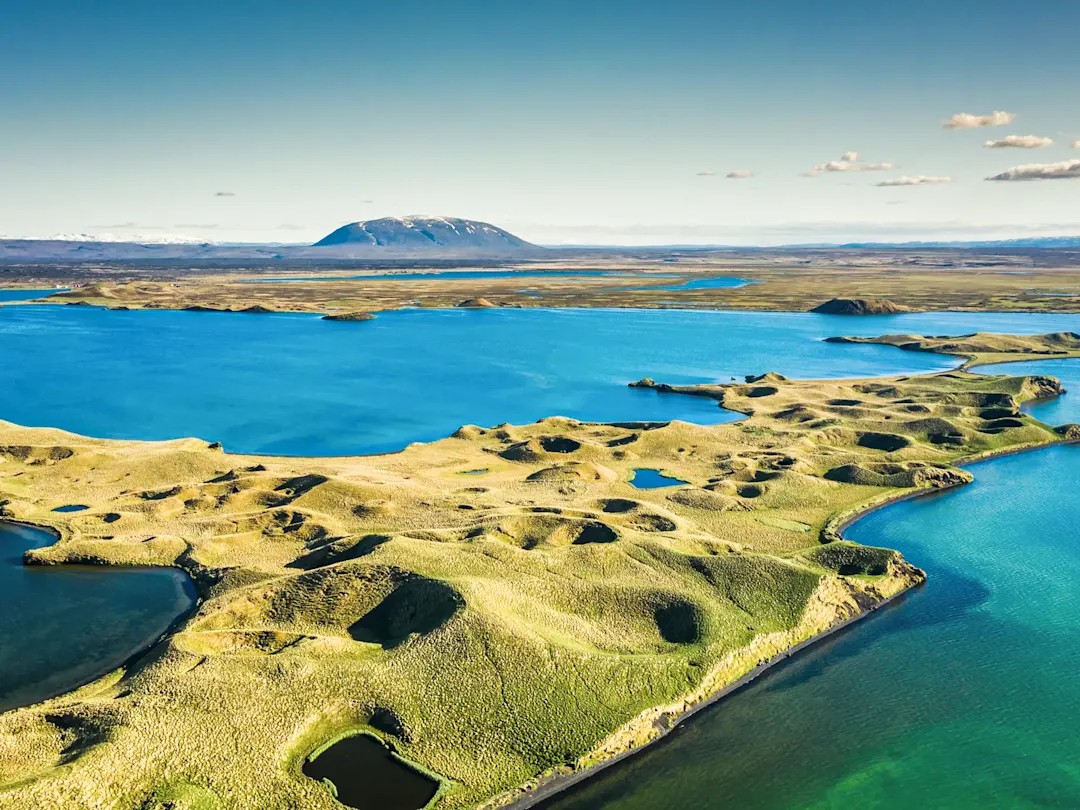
0, 522, 195, 712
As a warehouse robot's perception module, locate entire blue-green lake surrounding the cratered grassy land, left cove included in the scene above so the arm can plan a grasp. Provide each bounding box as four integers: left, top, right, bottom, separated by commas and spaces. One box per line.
6, 306, 1080, 810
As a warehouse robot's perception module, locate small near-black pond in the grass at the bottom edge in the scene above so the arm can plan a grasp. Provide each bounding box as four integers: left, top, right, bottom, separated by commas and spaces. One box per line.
303, 734, 438, 810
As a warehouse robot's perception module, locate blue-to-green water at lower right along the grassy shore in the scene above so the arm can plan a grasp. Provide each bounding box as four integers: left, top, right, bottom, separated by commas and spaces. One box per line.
544, 438, 1080, 810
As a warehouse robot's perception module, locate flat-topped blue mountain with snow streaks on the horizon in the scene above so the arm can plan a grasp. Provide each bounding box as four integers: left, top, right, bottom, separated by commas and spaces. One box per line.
312, 216, 542, 256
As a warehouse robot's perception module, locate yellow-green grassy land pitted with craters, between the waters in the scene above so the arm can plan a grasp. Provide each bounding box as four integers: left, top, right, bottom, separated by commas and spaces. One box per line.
0, 356, 1063, 810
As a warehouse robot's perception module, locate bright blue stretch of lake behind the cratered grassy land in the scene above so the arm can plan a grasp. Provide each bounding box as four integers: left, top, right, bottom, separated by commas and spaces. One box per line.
0, 305, 1080, 455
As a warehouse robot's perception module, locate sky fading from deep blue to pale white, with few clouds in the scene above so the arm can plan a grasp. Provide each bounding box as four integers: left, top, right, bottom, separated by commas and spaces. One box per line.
0, 0, 1080, 245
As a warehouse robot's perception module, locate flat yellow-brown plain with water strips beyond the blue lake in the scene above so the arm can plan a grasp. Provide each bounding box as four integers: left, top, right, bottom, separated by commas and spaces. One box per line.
8, 248, 1080, 312
